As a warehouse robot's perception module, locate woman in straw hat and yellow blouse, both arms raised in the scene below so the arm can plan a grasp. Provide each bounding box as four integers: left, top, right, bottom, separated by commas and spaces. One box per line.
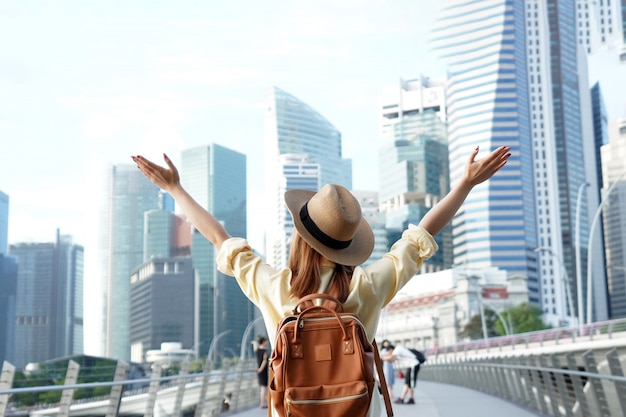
132, 146, 511, 416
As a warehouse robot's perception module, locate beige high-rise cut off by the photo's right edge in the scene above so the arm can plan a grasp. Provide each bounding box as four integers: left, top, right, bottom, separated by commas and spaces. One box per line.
602, 119, 626, 319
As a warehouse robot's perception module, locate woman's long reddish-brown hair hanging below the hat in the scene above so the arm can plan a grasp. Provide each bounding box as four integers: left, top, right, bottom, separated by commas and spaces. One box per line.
288, 230, 354, 303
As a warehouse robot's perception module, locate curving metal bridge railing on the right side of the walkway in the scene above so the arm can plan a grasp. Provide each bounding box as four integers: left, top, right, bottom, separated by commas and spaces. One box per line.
420, 349, 626, 417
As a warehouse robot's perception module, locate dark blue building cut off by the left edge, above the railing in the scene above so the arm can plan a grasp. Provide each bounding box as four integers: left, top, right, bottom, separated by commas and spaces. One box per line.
0, 253, 17, 363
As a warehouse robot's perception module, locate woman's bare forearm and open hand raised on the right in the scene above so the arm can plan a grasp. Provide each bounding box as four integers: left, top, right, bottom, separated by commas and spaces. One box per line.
419, 146, 511, 236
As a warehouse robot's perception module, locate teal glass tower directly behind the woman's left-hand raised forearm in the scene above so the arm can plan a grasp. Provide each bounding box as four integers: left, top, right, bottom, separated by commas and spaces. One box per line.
180, 144, 254, 356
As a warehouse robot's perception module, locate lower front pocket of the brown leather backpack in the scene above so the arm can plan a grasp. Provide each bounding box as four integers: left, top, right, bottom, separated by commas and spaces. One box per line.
285, 381, 370, 417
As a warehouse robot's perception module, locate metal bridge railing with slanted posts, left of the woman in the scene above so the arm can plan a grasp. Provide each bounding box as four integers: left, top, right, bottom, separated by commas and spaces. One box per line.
0, 360, 259, 417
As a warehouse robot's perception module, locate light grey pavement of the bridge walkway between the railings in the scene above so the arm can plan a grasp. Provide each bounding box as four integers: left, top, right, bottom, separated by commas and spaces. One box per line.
233, 381, 542, 417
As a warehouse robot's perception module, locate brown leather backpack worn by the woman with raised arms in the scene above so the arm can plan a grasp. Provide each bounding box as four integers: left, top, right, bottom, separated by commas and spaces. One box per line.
269, 294, 393, 417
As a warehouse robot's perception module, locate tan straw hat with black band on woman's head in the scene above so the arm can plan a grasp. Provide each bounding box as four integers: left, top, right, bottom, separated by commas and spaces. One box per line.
285, 184, 374, 266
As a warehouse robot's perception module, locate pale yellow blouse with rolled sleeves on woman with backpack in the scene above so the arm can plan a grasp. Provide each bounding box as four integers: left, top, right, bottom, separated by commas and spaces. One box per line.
217, 225, 439, 345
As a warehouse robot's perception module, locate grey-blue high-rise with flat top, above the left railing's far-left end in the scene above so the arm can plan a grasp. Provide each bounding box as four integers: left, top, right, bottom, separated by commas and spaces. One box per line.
9, 230, 84, 367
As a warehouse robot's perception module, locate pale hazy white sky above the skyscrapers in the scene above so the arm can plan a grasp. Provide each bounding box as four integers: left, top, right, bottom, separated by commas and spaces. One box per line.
0, 0, 443, 250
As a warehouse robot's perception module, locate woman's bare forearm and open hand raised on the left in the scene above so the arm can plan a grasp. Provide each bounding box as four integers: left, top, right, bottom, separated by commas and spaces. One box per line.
131, 154, 230, 250
